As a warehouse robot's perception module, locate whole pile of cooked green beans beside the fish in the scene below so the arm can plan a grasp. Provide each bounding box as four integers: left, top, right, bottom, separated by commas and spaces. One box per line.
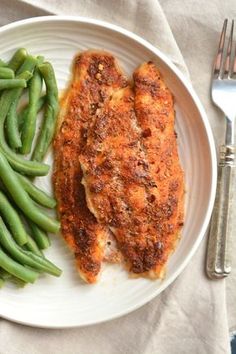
0, 48, 61, 288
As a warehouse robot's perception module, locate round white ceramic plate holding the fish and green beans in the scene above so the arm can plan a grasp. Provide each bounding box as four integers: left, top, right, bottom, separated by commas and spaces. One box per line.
0, 17, 216, 328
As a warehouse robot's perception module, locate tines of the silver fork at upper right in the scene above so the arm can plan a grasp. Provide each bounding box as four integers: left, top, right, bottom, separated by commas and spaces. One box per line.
213, 19, 236, 79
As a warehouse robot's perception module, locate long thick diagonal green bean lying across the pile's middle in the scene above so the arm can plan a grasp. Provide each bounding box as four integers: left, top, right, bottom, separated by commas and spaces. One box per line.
0, 153, 60, 233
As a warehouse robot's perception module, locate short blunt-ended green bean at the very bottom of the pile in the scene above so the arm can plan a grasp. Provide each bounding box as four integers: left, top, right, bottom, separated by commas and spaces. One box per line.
0, 247, 38, 283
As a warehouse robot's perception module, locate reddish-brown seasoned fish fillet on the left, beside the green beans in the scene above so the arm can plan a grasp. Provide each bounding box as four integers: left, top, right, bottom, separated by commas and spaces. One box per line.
53, 51, 127, 283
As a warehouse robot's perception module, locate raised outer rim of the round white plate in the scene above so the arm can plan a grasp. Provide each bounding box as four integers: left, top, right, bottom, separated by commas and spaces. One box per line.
0, 15, 217, 329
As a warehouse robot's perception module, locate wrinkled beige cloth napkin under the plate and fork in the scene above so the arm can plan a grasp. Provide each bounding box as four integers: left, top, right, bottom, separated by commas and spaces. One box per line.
0, 0, 236, 354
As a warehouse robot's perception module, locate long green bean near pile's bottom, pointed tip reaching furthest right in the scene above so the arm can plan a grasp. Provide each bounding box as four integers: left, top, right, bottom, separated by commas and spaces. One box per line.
0, 218, 61, 276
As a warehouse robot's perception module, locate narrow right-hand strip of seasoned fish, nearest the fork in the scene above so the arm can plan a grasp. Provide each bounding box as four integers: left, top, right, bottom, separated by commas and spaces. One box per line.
134, 62, 184, 272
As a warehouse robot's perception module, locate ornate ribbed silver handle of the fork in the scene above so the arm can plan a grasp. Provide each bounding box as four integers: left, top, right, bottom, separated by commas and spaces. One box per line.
206, 145, 236, 279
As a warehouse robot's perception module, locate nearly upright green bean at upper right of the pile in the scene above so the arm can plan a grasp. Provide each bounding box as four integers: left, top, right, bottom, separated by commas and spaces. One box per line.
32, 63, 59, 161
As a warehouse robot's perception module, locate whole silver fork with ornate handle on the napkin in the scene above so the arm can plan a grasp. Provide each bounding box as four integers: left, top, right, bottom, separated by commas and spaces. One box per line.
206, 20, 236, 279
